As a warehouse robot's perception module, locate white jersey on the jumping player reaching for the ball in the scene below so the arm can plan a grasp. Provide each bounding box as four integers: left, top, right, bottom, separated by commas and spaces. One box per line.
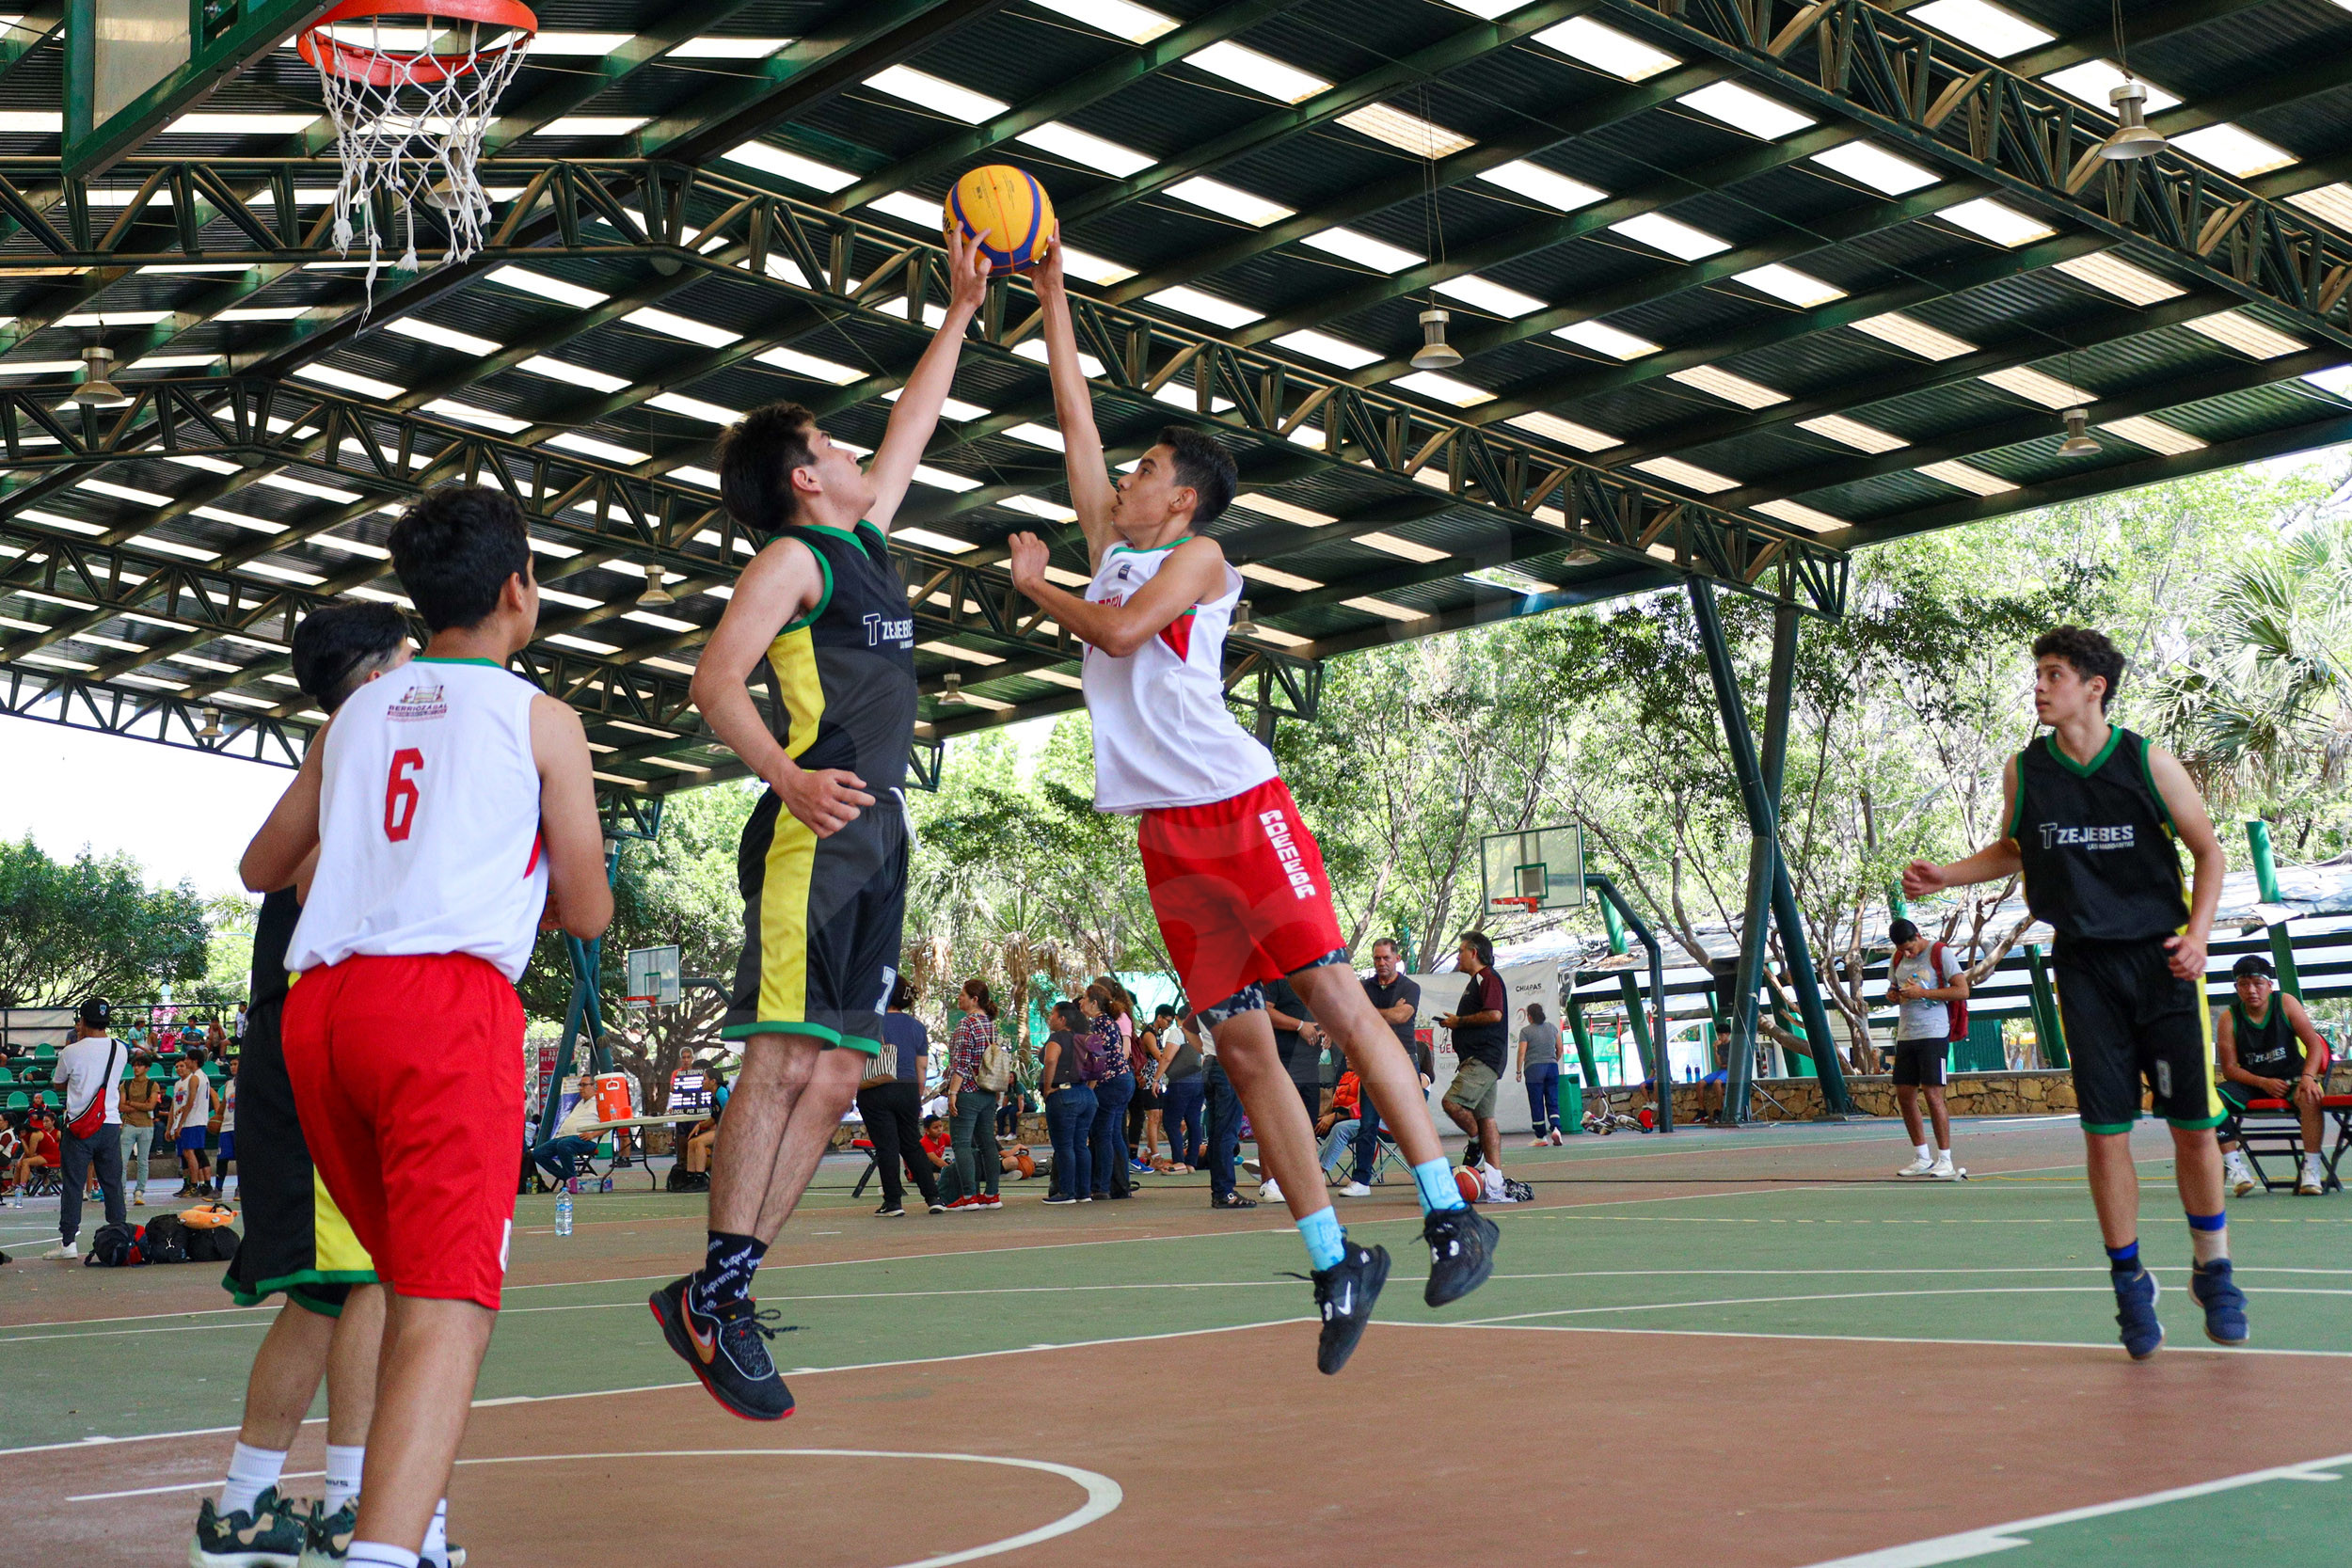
1085, 541, 1275, 814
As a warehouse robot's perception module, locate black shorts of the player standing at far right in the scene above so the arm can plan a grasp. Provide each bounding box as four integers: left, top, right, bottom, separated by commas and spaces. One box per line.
2054, 936, 2228, 1133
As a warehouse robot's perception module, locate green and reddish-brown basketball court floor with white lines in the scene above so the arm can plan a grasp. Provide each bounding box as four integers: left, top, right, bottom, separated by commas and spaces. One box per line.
0, 1121, 2352, 1568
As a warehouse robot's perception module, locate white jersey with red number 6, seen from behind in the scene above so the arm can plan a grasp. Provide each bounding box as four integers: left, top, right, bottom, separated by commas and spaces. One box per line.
287, 658, 548, 980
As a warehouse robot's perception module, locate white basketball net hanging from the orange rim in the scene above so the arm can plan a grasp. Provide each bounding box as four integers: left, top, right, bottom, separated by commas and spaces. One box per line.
320, 24, 532, 303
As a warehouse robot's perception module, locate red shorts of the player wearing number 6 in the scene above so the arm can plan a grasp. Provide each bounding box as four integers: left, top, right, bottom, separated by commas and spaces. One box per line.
282, 952, 522, 1312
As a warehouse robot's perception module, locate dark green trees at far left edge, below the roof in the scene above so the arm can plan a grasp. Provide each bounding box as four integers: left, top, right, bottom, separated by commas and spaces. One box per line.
0, 837, 207, 1006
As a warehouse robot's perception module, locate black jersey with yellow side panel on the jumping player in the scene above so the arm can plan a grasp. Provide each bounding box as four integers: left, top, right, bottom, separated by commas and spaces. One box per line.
765, 522, 915, 790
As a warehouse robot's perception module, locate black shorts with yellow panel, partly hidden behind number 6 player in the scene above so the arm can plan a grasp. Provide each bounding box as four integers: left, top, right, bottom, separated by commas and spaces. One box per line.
221, 997, 376, 1317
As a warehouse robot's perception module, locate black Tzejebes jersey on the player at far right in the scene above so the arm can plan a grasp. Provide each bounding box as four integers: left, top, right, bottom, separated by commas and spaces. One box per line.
2009, 726, 2190, 942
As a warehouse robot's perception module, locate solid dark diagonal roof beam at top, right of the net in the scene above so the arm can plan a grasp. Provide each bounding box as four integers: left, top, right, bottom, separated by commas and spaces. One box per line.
630, 0, 1011, 162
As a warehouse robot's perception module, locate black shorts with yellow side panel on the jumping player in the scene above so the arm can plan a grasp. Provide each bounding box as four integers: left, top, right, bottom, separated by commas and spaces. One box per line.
720, 790, 908, 1055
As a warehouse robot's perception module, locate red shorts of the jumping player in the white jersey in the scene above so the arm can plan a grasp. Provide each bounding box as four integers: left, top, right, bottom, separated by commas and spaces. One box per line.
1136, 778, 1348, 1008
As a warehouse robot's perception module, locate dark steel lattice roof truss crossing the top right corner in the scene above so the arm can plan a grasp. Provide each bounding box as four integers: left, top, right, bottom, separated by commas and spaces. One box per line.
1604, 0, 2352, 345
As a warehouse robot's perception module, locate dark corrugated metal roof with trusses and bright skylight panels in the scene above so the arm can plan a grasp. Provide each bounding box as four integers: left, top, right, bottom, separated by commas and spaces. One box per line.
0, 0, 2352, 804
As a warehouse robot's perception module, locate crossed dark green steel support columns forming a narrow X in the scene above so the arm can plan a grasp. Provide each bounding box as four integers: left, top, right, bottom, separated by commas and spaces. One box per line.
1692, 578, 1849, 1121
